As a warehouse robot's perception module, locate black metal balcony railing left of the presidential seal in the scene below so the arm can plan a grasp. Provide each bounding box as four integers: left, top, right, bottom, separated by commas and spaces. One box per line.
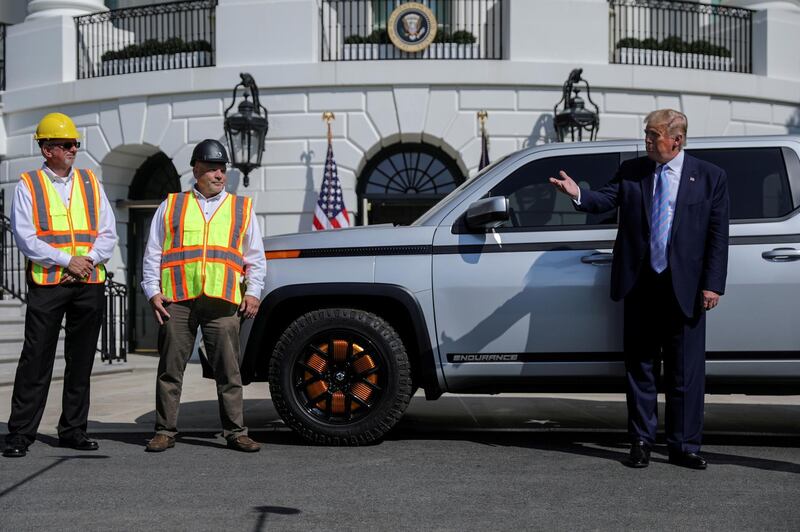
75, 0, 217, 79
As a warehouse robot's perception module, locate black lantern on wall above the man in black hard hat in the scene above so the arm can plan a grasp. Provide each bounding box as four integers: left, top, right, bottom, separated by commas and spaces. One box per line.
224, 72, 269, 186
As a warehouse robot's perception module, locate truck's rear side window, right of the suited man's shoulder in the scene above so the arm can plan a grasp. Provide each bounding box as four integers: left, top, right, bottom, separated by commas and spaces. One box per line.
687, 148, 797, 220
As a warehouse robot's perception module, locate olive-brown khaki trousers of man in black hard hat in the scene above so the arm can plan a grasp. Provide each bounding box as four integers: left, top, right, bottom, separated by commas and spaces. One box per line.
156, 296, 247, 440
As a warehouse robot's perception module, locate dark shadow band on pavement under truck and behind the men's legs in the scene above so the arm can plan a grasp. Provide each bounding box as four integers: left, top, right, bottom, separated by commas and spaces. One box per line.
0, 395, 800, 474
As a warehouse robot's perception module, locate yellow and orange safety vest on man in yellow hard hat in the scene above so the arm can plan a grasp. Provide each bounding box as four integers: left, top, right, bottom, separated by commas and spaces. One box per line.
20, 168, 106, 285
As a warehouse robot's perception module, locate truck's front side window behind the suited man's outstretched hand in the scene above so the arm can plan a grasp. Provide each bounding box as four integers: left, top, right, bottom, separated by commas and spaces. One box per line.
489, 152, 620, 229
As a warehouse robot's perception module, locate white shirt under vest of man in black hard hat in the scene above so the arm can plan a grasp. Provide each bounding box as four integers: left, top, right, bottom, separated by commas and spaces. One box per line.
142, 187, 267, 301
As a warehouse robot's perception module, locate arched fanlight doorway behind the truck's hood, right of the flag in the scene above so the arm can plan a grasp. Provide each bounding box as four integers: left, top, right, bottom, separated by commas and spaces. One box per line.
356, 142, 464, 225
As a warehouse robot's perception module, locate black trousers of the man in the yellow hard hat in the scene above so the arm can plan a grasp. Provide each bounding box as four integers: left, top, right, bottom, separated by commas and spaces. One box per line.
6, 282, 104, 443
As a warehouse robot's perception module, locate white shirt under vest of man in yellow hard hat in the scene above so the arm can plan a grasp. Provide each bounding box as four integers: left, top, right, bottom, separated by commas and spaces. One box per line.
11, 164, 117, 268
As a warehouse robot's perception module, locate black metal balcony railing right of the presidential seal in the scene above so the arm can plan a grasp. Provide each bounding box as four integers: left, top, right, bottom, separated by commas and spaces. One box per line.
609, 0, 753, 73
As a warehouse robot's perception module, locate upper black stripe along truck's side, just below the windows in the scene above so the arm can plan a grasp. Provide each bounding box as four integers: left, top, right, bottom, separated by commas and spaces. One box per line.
292, 234, 800, 258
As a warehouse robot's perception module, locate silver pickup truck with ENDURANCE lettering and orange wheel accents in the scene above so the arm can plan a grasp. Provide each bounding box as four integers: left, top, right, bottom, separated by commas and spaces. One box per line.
242, 136, 800, 445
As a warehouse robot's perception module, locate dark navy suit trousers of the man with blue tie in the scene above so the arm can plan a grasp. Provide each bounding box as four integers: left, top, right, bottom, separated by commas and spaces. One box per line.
624, 266, 706, 452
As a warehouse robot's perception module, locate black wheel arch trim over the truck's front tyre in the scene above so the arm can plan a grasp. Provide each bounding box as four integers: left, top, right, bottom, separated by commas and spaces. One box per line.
242, 283, 442, 399
